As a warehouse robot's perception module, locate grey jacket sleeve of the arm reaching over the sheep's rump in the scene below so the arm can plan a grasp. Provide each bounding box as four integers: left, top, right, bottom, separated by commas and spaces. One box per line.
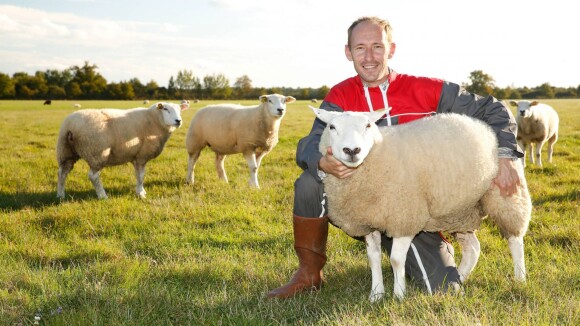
437, 82, 524, 158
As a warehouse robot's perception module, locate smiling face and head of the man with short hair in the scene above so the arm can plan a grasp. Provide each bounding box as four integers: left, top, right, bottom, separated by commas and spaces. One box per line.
345, 22, 395, 87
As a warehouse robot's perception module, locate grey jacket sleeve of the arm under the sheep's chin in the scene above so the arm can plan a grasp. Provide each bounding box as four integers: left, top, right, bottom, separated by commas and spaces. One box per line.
296, 101, 344, 181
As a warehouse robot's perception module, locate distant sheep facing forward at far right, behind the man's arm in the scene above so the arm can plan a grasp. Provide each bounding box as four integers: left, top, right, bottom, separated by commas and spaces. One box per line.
510, 101, 559, 167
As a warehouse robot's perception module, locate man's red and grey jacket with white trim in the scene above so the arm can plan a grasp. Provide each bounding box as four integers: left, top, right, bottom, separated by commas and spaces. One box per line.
296, 70, 523, 179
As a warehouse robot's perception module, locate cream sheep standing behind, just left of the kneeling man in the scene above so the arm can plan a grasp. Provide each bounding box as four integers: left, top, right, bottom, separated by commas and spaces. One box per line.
185, 94, 296, 188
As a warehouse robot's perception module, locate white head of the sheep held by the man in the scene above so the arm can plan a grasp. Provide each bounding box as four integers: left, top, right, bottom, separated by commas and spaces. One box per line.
310, 107, 385, 167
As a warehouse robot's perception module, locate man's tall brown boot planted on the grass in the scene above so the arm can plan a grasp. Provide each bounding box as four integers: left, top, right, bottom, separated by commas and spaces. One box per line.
268, 215, 328, 299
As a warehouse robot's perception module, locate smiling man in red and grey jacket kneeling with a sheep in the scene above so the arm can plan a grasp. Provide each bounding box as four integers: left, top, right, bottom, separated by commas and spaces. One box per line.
268, 17, 523, 298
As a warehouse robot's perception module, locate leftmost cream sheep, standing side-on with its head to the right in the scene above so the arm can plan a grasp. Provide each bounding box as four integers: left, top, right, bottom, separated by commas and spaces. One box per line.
56, 103, 189, 199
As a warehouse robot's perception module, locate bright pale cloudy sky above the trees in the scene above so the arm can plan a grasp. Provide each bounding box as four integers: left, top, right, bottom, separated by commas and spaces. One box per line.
0, 0, 580, 88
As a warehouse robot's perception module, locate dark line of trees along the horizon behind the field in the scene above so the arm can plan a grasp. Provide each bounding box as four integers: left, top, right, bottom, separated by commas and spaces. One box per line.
0, 61, 580, 100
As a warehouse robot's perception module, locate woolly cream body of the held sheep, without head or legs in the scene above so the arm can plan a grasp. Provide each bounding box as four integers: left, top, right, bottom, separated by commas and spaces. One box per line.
325, 114, 497, 236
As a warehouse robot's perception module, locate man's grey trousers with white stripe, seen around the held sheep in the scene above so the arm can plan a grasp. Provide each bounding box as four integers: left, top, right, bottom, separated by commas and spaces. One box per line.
294, 171, 460, 293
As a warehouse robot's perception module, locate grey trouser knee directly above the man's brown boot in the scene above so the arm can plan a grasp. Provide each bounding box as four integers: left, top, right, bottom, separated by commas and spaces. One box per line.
294, 171, 328, 217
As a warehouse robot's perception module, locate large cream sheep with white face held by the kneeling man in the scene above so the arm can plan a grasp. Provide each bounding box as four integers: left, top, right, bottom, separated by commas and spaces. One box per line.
312, 108, 532, 302
